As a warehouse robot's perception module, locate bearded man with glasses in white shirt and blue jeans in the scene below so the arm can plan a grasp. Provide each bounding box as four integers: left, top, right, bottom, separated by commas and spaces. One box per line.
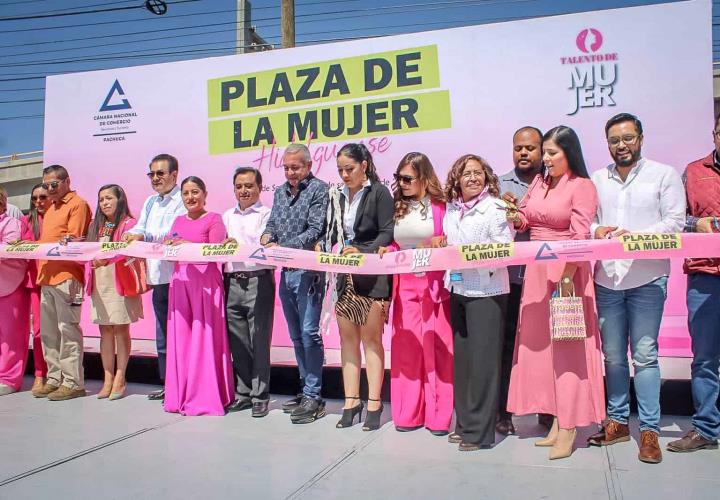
588, 113, 685, 463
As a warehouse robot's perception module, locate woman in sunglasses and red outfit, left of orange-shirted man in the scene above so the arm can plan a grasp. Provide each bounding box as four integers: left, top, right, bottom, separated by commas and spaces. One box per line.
21, 184, 50, 394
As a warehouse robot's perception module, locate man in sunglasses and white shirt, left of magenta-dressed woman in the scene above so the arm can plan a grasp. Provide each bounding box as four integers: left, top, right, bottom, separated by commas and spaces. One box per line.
123, 154, 187, 400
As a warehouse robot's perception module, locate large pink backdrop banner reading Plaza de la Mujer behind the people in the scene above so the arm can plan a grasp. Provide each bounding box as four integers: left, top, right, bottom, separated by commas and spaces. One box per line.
44, 0, 713, 355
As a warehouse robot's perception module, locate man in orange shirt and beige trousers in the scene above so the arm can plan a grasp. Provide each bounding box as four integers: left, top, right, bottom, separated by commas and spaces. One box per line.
33, 165, 92, 401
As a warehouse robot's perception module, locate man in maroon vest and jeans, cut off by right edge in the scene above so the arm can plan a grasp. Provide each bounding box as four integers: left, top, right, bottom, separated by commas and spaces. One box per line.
667, 115, 720, 453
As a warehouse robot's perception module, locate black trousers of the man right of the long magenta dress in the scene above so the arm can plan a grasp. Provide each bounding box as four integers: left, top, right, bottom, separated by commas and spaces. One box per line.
225, 271, 275, 402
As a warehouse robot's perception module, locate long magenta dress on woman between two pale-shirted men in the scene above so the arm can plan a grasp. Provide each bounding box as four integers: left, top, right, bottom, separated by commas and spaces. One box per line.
164, 212, 234, 415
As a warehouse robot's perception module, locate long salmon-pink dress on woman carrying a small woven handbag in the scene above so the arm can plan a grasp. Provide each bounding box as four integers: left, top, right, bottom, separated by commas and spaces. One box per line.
507, 175, 605, 429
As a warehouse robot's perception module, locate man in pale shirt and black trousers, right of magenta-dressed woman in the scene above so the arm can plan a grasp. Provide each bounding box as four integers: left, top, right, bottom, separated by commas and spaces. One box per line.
223, 167, 275, 417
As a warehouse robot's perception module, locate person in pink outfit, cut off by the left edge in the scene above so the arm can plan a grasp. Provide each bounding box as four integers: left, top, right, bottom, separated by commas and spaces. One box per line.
0, 187, 30, 396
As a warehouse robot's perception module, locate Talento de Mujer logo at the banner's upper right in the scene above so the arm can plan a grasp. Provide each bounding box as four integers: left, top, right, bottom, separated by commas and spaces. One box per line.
560, 28, 618, 116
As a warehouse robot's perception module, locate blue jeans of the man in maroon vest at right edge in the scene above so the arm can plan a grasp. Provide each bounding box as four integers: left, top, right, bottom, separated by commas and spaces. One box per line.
687, 273, 720, 439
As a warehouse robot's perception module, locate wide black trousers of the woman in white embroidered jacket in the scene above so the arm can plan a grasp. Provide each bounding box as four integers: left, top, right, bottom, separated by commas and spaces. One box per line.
450, 293, 507, 446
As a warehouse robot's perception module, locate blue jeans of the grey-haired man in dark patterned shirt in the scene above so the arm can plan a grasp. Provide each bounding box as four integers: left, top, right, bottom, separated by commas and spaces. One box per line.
280, 270, 325, 399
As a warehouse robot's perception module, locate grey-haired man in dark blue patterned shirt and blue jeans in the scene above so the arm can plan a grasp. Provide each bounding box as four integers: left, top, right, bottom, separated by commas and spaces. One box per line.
260, 144, 328, 424
